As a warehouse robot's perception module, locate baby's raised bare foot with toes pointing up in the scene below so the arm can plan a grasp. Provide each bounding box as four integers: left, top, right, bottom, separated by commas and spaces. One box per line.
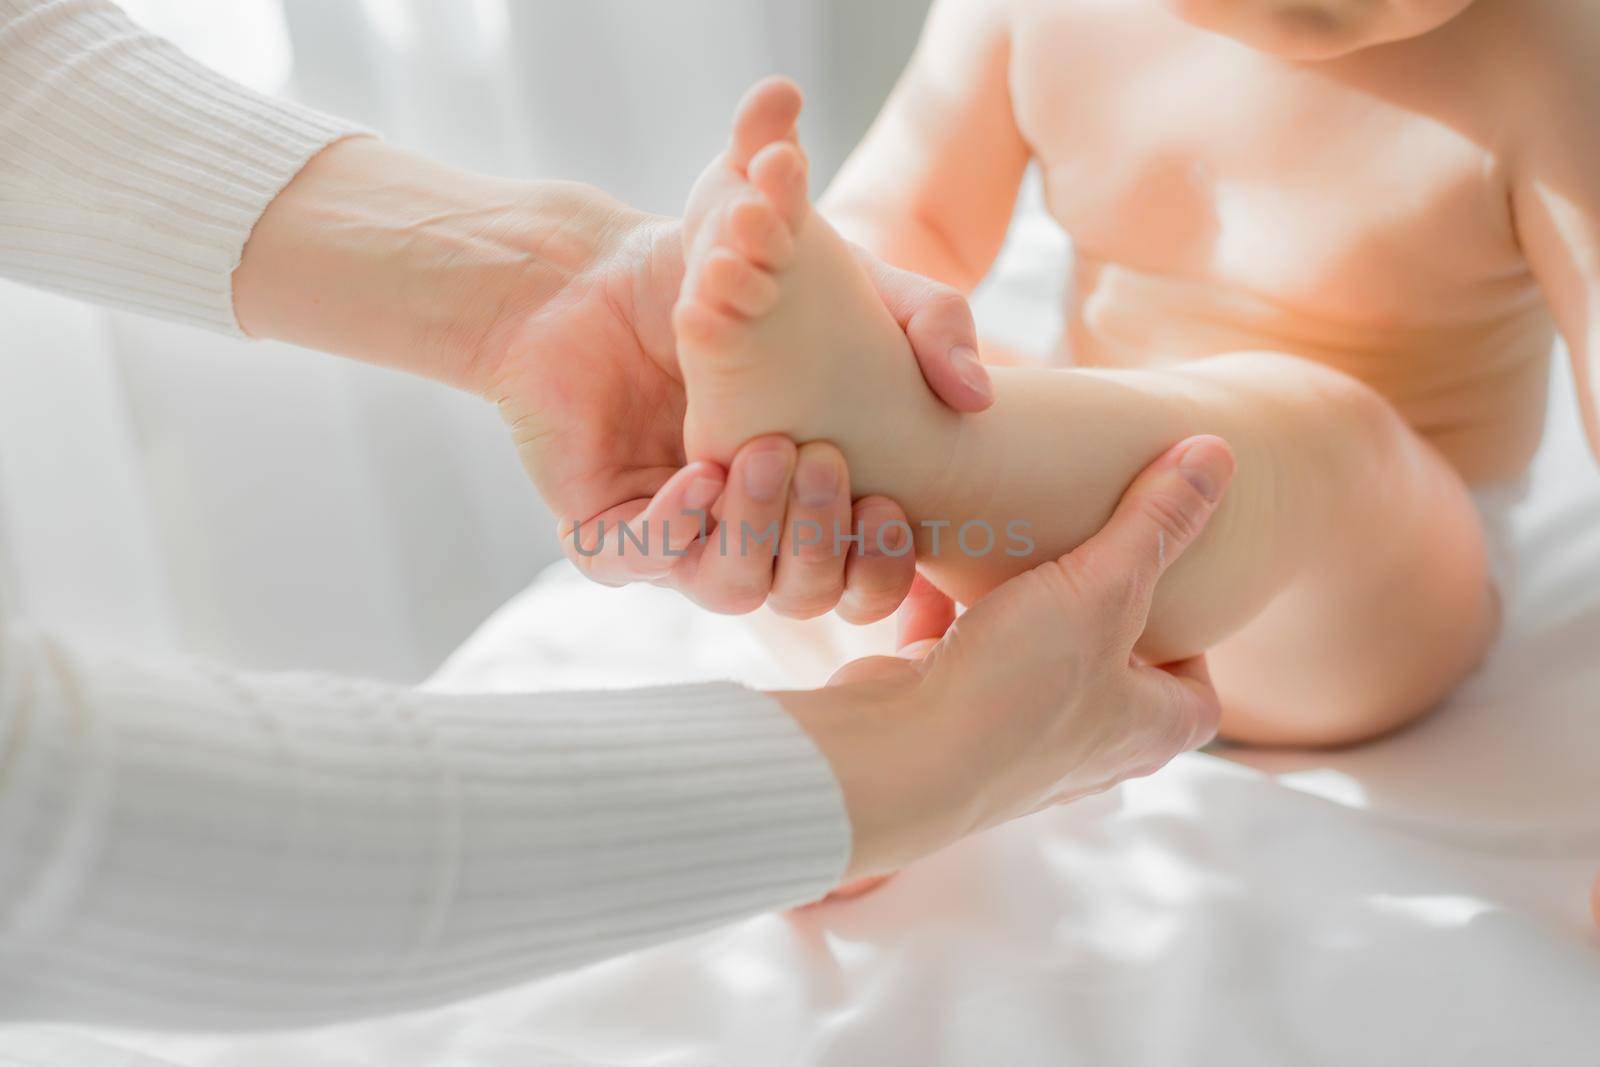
674, 78, 954, 507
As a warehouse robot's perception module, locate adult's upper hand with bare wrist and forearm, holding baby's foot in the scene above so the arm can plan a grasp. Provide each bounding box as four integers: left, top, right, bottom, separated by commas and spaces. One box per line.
234, 138, 992, 621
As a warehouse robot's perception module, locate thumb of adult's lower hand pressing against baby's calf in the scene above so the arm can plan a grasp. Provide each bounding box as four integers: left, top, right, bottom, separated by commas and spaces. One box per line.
1066, 437, 1235, 638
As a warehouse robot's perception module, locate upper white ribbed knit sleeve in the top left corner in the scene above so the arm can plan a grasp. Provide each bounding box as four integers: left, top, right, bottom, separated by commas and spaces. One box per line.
0, 0, 362, 334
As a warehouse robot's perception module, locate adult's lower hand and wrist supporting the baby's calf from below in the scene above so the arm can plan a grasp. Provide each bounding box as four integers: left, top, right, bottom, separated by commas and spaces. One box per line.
779, 437, 1234, 880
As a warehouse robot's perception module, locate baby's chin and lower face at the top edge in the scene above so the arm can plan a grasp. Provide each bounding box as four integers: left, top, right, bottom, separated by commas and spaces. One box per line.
1171, 0, 1472, 62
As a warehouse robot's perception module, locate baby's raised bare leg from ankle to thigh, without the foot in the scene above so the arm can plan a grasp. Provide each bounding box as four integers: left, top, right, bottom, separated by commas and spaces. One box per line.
921, 354, 1498, 744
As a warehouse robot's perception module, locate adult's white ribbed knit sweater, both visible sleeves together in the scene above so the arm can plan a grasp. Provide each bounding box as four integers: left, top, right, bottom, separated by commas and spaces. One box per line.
0, 0, 850, 1027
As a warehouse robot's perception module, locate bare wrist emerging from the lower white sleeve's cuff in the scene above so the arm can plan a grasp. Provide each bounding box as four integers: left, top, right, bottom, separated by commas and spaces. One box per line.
773, 675, 966, 883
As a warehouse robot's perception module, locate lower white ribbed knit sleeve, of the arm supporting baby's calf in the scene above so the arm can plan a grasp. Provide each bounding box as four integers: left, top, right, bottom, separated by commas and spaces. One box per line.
0, 629, 850, 1029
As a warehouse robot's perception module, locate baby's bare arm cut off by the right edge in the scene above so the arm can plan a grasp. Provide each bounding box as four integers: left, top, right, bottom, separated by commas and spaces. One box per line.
1512, 5, 1600, 458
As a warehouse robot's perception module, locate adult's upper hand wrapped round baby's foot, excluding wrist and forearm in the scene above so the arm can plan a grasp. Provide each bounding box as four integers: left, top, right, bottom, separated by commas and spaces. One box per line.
485, 206, 992, 622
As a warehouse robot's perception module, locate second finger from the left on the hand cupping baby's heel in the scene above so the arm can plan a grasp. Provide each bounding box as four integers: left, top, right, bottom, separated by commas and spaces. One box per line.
678, 437, 798, 614
